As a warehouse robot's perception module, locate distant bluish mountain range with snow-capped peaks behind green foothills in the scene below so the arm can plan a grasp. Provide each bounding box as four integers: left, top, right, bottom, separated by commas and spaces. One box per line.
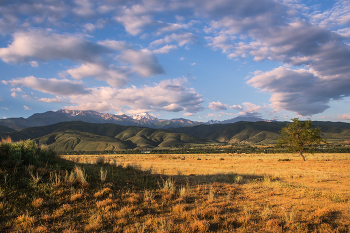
0, 109, 263, 132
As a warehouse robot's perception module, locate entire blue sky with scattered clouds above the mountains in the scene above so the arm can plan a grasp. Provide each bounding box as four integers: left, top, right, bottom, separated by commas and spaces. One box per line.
0, 0, 350, 122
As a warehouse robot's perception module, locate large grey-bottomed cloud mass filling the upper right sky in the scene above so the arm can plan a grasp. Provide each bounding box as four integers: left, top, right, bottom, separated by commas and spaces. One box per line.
197, 0, 350, 115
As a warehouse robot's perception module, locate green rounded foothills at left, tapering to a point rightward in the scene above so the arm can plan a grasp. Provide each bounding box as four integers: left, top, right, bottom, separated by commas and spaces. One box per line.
0, 121, 208, 152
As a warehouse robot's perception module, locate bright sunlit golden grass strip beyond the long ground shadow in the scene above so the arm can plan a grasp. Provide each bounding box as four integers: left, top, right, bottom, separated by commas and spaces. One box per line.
63, 153, 350, 194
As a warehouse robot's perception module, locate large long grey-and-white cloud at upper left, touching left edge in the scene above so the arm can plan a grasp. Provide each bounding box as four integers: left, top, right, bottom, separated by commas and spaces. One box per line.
0, 30, 165, 87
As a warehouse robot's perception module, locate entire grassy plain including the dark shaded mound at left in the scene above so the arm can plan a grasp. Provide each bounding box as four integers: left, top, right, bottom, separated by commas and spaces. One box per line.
0, 141, 350, 233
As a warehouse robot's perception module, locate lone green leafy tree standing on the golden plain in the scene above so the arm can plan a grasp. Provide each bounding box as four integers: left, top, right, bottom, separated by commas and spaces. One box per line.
277, 118, 326, 161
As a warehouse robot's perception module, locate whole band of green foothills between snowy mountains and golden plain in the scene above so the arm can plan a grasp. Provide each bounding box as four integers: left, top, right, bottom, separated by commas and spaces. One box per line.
0, 117, 350, 152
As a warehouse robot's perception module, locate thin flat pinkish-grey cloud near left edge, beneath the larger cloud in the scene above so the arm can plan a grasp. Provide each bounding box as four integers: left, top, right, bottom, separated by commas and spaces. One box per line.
2, 76, 90, 95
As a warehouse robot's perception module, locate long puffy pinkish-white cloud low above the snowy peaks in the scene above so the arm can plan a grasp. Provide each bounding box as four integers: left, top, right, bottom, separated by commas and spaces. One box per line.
66, 79, 203, 114
